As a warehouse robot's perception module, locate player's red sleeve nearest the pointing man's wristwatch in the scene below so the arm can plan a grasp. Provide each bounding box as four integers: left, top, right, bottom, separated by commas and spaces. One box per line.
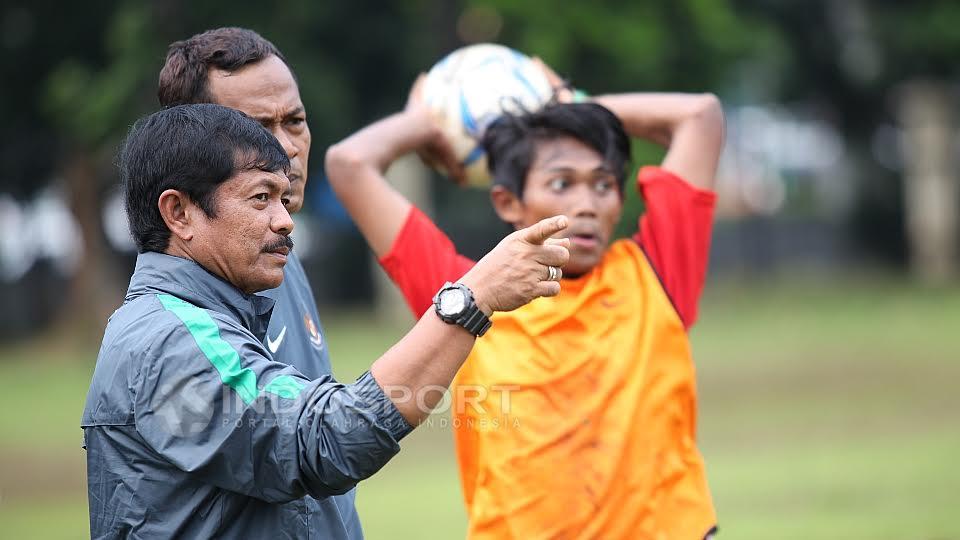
380, 206, 475, 317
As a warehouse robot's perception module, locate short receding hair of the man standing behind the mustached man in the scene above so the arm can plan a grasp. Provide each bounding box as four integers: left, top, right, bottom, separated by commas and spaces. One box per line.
157, 27, 293, 107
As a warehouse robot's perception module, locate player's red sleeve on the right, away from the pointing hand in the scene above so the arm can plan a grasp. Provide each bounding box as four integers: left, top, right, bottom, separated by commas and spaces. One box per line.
633, 167, 717, 328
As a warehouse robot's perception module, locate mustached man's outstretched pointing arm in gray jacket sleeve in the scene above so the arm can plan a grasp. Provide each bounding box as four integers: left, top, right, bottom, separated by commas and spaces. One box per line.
137, 216, 569, 503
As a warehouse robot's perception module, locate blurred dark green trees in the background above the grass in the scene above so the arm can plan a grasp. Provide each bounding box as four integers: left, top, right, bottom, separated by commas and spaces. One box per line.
7, 0, 960, 337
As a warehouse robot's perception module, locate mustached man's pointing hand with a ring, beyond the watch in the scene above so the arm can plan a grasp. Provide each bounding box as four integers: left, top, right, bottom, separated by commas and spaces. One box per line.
460, 216, 570, 315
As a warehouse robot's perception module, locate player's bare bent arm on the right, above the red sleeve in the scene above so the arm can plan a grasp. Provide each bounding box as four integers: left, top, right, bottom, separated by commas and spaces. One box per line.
593, 93, 724, 190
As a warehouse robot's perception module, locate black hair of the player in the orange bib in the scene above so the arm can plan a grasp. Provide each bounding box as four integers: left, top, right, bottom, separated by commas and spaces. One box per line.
481, 103, 630, 198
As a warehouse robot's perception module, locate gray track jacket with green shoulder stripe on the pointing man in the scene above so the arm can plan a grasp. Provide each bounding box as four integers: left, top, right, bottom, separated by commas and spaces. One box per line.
81, 253, 411, 538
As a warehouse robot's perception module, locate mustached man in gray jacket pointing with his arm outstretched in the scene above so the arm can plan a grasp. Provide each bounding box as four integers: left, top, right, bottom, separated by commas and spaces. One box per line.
82, 105, 568, 538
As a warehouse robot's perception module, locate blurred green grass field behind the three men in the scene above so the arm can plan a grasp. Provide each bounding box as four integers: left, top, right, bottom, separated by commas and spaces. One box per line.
0, 280, 960, 540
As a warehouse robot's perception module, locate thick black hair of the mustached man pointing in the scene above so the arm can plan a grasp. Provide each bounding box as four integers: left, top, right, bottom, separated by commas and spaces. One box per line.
118, 103, 290, 253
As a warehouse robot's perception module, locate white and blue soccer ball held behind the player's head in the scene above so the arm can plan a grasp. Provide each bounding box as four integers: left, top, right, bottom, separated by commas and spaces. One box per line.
423, 43, 553, 187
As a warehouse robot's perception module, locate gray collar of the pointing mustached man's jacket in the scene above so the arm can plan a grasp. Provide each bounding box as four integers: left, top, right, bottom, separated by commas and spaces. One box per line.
124, 251, 274, 341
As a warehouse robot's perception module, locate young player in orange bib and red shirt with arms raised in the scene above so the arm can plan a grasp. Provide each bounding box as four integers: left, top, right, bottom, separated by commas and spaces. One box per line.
327, 70, 723, 540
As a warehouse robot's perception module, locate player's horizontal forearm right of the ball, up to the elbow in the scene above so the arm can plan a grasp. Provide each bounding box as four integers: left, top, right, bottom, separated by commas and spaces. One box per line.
593, 93, 723, 146
